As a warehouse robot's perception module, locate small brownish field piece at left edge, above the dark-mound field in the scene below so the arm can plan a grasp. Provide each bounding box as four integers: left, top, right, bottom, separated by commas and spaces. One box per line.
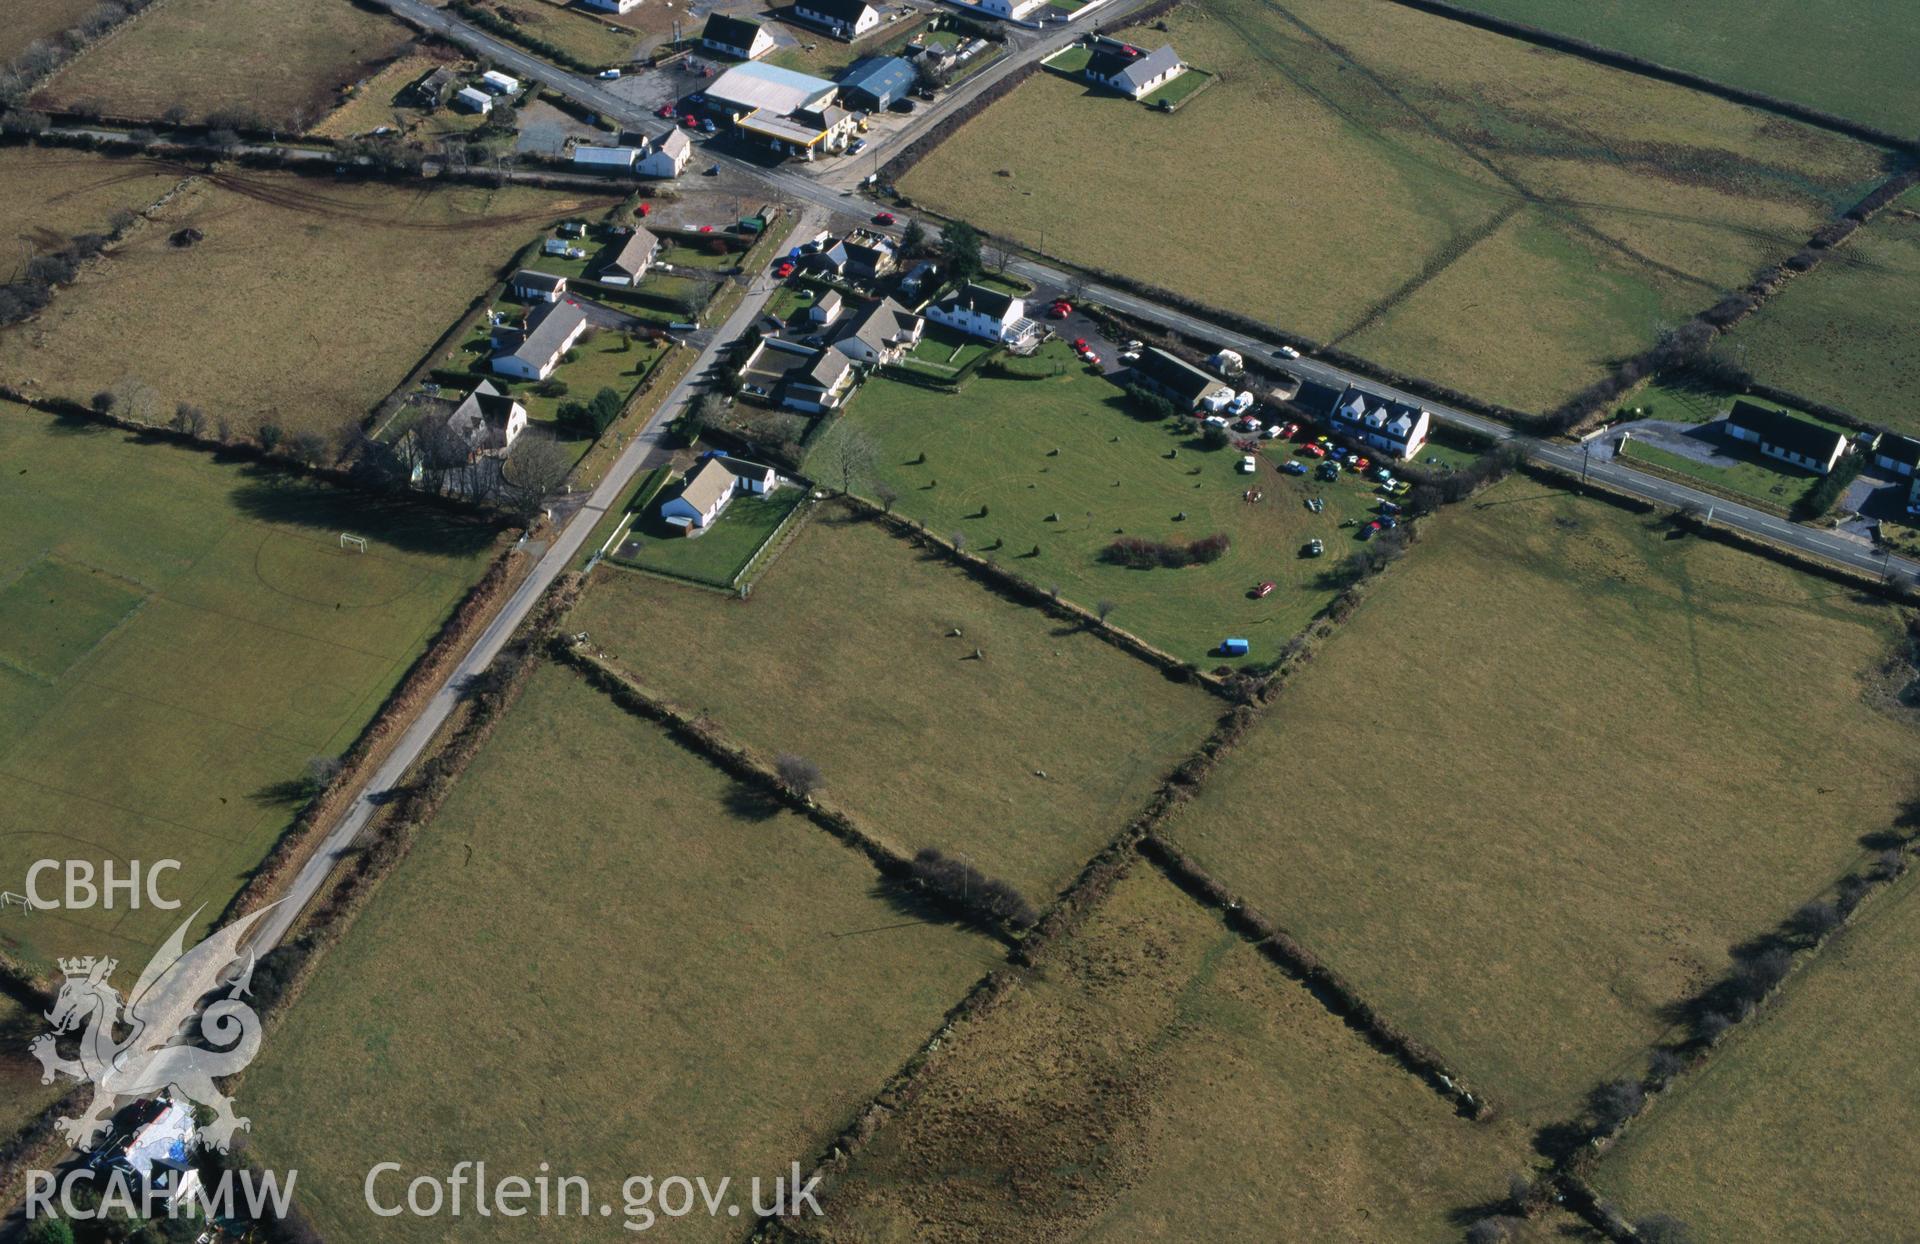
0, 146, 188, 251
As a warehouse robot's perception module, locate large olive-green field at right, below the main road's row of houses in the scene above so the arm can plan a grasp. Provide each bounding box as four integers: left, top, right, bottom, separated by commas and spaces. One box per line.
1171, 478, 1920, 1121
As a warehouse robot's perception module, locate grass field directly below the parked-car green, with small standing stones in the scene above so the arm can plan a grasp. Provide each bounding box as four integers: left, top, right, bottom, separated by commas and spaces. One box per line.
568, 509, 1219, 904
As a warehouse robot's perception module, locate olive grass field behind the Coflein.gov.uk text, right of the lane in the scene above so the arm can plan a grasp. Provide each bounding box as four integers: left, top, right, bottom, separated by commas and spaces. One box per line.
242, 666, 1000, 1242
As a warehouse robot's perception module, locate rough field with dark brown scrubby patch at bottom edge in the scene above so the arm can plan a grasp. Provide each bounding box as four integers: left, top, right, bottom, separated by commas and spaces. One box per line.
808, 864, 1544, 1244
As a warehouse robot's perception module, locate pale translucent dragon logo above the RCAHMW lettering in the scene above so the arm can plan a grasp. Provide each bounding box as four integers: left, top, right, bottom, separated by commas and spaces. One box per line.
27, 906, 273, 1154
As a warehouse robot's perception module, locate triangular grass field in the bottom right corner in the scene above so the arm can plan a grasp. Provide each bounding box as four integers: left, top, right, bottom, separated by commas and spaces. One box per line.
1594, 871, 1920, 1244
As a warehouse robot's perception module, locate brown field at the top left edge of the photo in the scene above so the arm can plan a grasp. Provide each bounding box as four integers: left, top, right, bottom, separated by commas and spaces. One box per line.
35, 0, 413, 131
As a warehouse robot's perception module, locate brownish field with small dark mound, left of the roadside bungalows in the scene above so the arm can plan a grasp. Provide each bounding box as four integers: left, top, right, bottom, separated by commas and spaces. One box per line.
0, 169, 611, 438
